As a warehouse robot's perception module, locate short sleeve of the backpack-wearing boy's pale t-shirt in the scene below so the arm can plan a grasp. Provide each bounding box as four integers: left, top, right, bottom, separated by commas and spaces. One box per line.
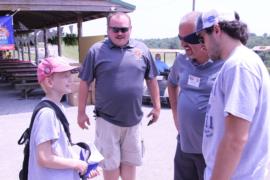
34, 108, 60, 145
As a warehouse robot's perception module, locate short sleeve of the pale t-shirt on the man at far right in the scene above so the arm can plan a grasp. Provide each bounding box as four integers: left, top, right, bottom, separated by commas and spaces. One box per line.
222, 66, 260, 121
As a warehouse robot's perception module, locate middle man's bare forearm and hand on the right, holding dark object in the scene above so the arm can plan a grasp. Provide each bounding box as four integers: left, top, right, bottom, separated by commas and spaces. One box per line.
146, 78, 160, 122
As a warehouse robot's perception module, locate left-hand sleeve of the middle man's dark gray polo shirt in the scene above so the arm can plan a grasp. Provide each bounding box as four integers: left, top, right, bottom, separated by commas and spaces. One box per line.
79, 49, 95, 83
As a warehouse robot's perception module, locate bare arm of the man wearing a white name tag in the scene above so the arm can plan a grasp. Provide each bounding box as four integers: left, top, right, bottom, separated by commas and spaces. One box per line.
168, 81, 180, 132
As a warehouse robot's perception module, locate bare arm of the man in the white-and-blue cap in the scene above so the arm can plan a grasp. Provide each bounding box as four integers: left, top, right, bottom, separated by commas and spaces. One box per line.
211, 114, 250, 180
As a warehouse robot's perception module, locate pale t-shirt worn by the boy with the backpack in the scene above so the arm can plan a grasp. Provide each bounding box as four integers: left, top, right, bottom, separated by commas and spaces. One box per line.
28, 101, 80, 180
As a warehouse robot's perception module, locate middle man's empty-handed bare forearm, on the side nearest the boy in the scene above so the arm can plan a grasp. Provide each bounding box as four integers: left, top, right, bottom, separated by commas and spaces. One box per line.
77, 80, 90, 129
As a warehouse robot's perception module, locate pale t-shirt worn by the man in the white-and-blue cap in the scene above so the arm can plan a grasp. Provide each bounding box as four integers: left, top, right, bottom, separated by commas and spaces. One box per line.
203, 46, 270, 180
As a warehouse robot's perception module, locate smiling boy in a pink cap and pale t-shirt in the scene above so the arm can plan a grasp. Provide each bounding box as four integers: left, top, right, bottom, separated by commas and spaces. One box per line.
28, 57, 98, 180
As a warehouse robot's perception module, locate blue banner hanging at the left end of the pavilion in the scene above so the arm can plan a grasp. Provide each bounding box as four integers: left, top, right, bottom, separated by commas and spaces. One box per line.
0, 16, 15, 50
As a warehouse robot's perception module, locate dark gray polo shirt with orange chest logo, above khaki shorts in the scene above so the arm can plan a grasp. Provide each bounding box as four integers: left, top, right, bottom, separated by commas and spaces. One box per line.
79, 39, 158, 127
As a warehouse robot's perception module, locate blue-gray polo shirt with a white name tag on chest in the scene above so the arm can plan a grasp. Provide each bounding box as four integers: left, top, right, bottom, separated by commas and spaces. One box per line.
168, 54, 224, 154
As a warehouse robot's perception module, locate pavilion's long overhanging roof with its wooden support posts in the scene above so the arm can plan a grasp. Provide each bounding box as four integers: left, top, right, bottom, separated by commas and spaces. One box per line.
0, 0, 135, 63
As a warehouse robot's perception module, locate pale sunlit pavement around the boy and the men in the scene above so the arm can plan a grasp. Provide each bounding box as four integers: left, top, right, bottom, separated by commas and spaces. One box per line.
0, 105, 176, 180
